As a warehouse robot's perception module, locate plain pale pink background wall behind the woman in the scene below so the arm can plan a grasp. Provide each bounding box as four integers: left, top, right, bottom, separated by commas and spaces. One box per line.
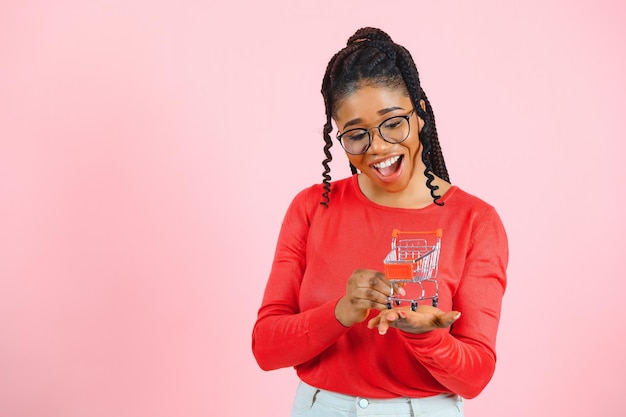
0, 0, 626, 417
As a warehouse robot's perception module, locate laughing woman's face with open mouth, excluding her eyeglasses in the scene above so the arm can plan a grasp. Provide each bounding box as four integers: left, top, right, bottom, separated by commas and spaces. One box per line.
335, 85, 424, 193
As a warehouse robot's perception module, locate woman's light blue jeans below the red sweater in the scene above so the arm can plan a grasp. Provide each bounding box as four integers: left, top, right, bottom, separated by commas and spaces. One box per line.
291, 382, 463, 417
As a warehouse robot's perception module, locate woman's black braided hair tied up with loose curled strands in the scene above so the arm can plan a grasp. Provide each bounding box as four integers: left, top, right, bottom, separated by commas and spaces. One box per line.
321, 27, 450, 207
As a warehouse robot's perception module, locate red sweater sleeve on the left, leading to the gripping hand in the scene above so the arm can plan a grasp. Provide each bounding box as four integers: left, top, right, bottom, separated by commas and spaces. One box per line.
252, 190, 348, 370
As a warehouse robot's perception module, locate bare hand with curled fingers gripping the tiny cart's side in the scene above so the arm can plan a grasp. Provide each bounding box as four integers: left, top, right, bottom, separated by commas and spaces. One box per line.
335, 269, 404, 327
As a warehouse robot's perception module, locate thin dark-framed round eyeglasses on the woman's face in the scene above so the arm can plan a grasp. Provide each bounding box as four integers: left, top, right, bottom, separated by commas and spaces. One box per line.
337, 109, 415, 155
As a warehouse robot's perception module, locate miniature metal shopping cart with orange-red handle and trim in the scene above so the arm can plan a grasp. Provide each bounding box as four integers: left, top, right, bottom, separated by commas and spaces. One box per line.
384, 229, 443, 311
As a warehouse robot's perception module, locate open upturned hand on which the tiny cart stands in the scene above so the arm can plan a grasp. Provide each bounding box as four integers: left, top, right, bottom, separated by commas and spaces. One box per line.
367, 305, 461, 335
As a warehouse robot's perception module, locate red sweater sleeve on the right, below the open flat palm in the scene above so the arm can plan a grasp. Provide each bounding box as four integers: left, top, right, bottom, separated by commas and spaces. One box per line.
404, 209, 508, 398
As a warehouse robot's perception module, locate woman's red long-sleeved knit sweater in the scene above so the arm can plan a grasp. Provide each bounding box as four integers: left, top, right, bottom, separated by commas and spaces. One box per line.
252, 176, 508, 398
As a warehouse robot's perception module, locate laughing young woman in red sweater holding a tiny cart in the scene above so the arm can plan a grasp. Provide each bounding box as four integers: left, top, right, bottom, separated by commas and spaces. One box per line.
252, 28, 508, 417
